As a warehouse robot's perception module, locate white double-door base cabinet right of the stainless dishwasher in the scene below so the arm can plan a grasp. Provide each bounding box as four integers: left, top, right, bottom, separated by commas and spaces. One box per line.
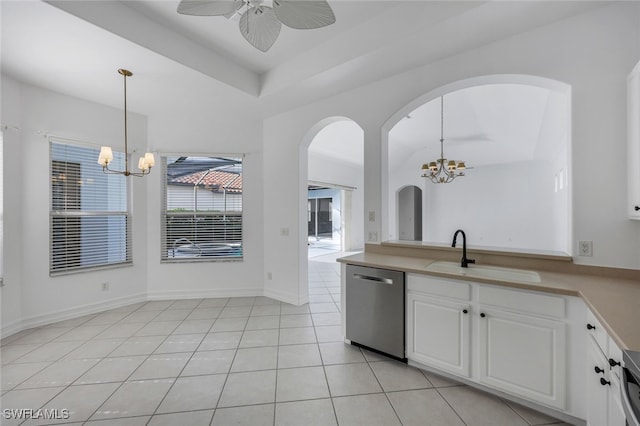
407, 274, 567, 409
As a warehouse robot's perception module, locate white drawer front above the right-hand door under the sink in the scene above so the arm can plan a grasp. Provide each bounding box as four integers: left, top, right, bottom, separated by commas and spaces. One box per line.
478, 285, 566, 318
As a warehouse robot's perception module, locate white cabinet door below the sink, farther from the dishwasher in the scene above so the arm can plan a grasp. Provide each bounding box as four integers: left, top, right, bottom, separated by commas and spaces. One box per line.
478, 306, 566, 409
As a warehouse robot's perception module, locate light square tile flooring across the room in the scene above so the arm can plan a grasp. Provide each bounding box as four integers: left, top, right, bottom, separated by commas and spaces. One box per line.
0, 261, 559, 426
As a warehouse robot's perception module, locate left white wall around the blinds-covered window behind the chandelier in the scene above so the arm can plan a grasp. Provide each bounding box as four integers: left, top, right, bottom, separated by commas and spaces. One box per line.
2, 75, 147, 334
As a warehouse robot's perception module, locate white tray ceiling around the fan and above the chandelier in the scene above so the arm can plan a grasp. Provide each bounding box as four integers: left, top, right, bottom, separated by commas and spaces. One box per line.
0, 0, 606, 165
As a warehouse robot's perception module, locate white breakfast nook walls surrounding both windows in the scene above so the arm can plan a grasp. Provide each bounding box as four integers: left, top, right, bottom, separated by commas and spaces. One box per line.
0, 75, 264, 335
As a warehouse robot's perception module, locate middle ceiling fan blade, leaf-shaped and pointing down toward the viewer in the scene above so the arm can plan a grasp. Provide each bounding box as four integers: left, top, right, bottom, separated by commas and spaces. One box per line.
240, 6, 282, 52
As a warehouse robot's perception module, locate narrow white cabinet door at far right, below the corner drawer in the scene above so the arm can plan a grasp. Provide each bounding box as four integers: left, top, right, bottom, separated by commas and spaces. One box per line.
587, 338, 609, 426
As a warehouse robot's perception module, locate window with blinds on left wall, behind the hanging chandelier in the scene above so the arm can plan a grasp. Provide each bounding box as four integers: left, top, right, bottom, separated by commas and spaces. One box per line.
49, 140, 131, 274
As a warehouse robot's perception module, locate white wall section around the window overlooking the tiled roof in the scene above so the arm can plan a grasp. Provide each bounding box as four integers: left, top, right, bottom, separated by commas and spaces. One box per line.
147, 93, 264, 299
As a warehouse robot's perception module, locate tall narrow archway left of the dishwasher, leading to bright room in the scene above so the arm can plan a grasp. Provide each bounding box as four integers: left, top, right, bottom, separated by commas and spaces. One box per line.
299, 117, 364, 303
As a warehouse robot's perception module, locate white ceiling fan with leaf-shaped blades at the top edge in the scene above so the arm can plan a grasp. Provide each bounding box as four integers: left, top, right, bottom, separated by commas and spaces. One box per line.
178, 0, 336, 52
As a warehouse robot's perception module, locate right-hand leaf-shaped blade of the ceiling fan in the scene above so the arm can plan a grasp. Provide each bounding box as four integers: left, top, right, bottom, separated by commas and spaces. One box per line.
273, 0, 336, 30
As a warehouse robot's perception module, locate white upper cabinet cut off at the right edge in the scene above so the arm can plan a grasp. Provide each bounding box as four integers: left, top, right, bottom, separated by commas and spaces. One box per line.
627, 63, 640, 220
